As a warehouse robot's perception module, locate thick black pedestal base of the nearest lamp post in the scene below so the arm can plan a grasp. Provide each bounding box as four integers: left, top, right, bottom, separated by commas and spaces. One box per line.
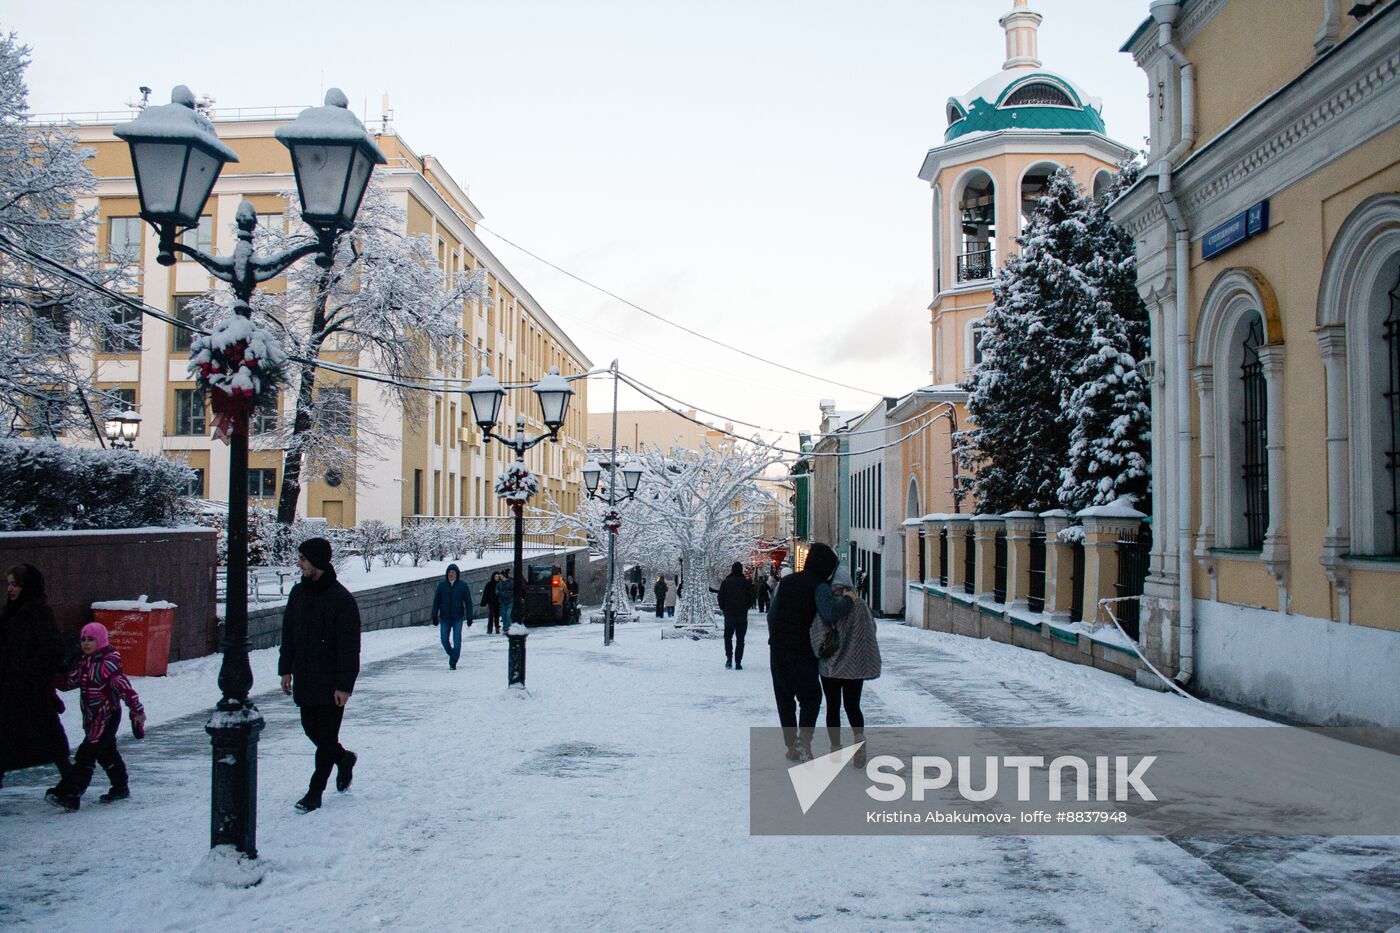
204, 698, 266, 859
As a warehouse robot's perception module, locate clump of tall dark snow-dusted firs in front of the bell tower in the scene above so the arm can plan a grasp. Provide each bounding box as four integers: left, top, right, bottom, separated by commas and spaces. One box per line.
962, 170, 1149, 513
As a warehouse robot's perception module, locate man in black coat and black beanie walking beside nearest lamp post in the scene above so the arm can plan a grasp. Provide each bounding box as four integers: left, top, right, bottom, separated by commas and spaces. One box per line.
277, 538, 360, 813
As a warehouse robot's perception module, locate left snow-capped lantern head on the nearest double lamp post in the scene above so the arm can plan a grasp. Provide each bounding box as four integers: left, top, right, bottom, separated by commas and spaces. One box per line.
112, 84, 238, 249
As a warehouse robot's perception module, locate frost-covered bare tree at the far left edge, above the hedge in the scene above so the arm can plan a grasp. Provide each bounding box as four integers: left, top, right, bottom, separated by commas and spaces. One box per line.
0, 32, 141, 437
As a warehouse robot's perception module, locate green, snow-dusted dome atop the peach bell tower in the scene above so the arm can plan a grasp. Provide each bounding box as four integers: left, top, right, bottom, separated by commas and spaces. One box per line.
944, 69, 1106, 143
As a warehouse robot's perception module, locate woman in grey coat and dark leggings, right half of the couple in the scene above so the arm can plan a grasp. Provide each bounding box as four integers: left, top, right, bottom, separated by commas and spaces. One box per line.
811, 570, 881, 769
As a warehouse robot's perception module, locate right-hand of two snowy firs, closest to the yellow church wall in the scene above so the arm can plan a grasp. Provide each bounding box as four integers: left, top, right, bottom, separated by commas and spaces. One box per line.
1057, 164, 1152, 510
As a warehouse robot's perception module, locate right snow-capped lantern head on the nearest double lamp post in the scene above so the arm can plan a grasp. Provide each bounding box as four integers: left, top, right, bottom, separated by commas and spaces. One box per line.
276, 87, 388, 230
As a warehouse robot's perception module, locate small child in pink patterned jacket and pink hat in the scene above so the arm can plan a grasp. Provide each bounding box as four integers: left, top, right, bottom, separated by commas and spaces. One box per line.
45, 622, 146, 810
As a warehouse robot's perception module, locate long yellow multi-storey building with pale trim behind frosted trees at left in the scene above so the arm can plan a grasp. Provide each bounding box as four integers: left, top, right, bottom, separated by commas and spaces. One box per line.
64, 111, 591, 527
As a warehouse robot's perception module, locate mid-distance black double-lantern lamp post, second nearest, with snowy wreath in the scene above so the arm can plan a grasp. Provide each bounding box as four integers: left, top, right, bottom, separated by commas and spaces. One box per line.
466, 367, 574, 688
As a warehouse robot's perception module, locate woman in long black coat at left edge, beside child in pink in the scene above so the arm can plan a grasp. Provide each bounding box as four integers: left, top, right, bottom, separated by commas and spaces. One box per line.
0, 563, 69, 780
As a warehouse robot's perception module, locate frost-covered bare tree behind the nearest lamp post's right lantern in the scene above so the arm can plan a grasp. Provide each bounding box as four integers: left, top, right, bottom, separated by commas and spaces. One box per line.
192, 179, 484, 524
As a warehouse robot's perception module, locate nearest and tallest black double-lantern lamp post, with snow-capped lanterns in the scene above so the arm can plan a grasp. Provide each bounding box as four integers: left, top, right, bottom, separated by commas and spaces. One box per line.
112, 84, 386, 859
